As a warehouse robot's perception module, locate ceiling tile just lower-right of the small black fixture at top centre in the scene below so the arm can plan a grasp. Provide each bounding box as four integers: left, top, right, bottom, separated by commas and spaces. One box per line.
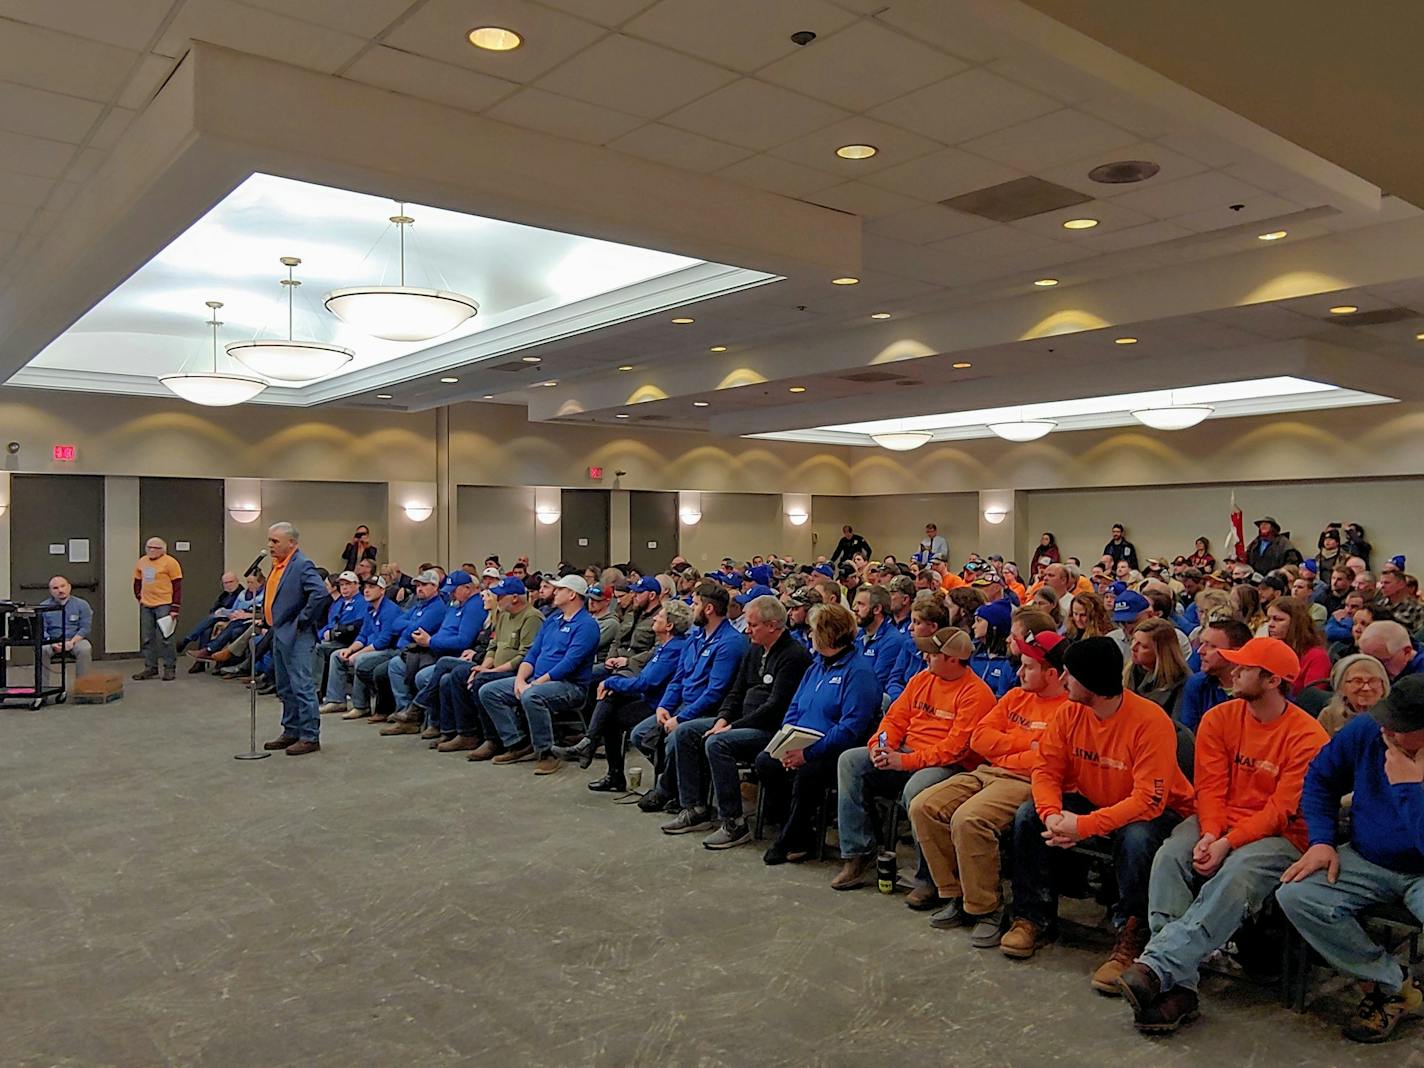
760, 21, 967, 111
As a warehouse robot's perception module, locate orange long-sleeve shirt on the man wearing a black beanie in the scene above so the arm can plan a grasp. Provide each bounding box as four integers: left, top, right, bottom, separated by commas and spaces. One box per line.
1032, 691, 1193, 837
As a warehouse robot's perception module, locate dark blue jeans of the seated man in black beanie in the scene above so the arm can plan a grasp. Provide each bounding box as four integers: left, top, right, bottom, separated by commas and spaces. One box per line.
1014, 793, 1182, 927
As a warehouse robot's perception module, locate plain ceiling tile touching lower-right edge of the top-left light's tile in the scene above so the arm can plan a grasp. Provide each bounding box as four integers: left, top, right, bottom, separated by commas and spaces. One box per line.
538, 34, 736, 118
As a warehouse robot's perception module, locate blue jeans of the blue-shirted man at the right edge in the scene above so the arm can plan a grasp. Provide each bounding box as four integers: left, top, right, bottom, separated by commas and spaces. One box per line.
1276, 846, 1424, 994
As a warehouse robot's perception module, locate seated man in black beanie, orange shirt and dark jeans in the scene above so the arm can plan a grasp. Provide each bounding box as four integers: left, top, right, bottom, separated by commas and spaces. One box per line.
998, 638, 1192, 995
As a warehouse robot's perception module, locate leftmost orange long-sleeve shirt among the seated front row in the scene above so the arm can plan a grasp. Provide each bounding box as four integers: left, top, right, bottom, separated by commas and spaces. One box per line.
869, 668, 996, 772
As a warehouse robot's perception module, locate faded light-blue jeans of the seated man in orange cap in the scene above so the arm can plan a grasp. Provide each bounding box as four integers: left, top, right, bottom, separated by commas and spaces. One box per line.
1138, 816, 1300, 990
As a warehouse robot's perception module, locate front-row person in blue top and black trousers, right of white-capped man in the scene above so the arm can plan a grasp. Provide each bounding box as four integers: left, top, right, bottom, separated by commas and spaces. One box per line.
572, 598, 692, 793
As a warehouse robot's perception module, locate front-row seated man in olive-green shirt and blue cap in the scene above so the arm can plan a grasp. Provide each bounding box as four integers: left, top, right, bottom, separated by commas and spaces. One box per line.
436, 578, 544, 760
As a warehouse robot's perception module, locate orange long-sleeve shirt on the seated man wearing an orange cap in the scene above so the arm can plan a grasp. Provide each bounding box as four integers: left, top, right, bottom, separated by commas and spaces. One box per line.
1196, 698, 1330, 850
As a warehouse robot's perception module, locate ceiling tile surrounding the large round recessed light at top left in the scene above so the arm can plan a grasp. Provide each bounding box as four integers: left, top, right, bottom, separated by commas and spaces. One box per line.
384, 0, 607, 83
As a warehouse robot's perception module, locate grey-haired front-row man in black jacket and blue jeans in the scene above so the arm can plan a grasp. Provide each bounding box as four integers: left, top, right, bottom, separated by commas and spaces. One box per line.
662, 597, 810, 849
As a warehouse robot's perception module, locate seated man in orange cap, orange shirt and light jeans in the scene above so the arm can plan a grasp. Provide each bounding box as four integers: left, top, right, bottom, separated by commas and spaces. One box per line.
1119, 638, 1330, 1034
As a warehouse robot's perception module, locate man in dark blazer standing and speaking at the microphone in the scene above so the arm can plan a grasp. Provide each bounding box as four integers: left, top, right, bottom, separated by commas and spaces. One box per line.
262, 523, 328, 756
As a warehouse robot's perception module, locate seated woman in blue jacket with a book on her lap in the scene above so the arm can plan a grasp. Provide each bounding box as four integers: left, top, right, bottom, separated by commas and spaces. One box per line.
749, 604, 881, 864
